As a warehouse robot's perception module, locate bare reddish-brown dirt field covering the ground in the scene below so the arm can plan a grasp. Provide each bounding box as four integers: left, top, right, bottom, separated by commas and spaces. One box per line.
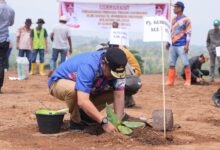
0, 71, 220, 150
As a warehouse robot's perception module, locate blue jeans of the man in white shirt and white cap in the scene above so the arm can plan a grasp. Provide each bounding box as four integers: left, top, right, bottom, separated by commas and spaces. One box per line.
50, 48, 67, 70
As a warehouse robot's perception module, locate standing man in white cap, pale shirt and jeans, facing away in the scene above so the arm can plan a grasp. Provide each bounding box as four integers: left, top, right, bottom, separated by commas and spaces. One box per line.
48, 16, 72, 76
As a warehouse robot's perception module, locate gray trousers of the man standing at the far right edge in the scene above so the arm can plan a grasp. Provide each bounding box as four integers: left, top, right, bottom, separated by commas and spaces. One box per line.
209, 50, 220, 78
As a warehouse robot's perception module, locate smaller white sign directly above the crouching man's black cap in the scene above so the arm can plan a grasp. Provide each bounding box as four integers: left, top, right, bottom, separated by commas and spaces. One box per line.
109, 28, 129, 47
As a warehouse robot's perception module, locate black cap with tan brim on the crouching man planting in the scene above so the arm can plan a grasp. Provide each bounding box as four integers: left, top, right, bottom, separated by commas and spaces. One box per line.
104, 47, 128, 79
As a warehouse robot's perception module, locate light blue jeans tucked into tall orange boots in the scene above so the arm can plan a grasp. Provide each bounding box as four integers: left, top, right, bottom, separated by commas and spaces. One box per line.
169, 46, 189, 67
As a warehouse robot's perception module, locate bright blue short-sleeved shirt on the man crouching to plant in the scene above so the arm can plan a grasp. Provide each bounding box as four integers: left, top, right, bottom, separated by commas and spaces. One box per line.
48, 51, 125, 95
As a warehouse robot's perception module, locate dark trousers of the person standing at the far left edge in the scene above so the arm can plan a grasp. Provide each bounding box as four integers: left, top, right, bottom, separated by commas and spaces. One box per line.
0, 42, 9, 87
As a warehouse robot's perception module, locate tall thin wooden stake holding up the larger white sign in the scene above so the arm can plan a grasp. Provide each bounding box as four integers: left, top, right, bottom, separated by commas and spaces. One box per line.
160, 26, 167, 138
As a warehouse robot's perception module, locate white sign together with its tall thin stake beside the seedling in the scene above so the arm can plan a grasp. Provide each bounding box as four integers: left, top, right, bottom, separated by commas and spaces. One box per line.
144, 17, 171, 138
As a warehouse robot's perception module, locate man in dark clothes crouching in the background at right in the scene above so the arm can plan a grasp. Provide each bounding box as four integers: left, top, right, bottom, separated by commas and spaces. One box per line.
181, 54, 209, 84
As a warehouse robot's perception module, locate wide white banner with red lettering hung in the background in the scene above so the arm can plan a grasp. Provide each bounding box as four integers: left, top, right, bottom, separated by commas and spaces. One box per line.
60, 0, 169, 32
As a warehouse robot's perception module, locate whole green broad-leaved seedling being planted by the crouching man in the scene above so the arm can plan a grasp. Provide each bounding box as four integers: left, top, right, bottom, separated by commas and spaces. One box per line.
106, 104, 145, 135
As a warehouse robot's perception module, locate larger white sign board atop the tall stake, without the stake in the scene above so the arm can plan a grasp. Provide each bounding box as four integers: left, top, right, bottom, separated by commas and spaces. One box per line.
144, 17, 171, 43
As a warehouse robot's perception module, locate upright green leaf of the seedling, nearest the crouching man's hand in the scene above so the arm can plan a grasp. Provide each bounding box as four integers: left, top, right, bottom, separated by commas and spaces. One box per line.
106, 103, 120, 128
